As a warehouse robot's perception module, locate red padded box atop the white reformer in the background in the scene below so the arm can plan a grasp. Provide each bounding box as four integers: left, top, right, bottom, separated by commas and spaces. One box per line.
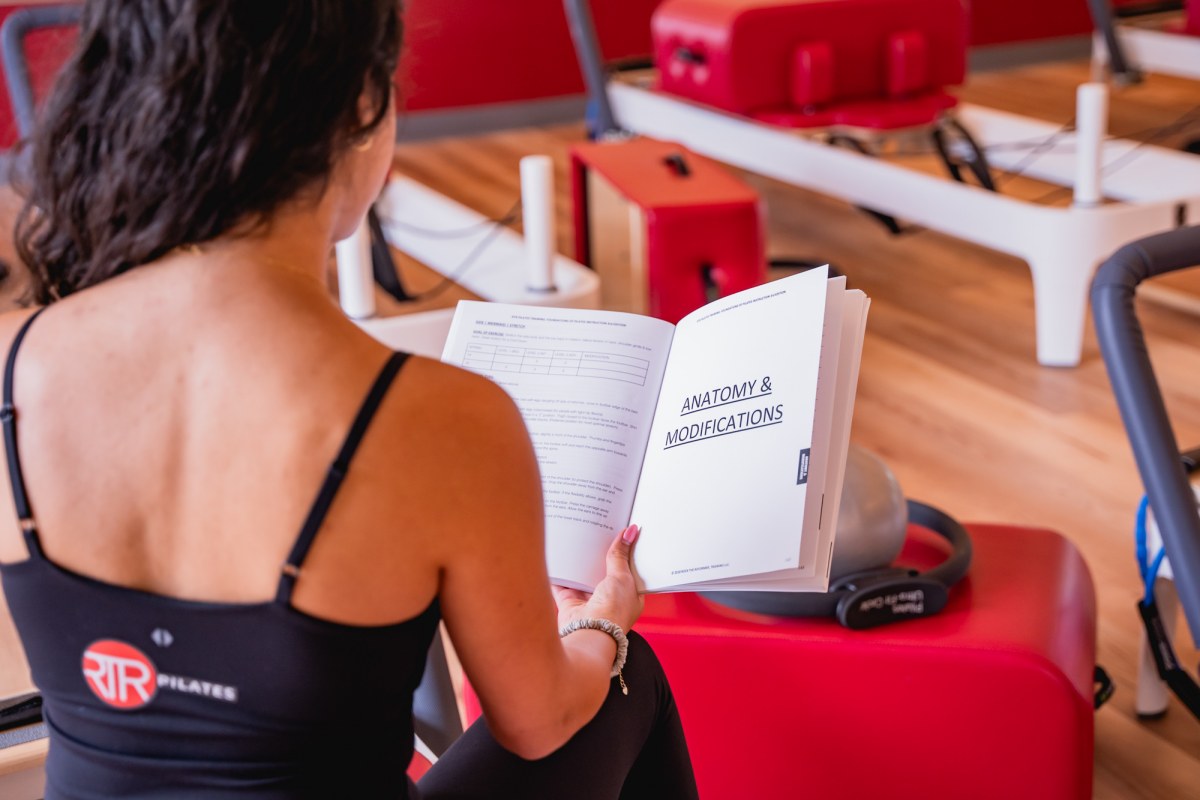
652, 0, 967, 128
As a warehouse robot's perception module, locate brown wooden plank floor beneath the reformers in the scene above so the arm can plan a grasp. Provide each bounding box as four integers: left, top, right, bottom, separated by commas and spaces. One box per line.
396, 57, 1200, 800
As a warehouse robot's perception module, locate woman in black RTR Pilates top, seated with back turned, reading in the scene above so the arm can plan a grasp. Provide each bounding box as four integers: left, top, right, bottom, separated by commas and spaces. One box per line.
0, 0, 695, 799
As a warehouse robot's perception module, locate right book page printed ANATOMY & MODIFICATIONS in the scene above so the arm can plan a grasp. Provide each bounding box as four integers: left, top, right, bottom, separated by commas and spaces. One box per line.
631, 267, 840, 591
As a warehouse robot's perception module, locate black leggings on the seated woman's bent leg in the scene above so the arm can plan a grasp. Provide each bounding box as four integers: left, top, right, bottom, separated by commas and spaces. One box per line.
418, 633, 697, 800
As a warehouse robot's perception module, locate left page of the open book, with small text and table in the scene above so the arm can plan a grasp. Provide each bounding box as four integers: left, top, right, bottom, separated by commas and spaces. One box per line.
442, 301, 674, 589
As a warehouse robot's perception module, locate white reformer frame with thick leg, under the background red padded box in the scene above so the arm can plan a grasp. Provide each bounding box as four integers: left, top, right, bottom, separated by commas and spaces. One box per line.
608, 77, 1200, 367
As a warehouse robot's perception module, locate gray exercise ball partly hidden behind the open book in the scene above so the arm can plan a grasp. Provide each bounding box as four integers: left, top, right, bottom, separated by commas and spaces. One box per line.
830, 445, 908, 581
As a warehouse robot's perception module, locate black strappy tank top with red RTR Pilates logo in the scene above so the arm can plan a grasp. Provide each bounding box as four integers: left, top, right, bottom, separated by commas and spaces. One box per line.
0, 312, 438, 800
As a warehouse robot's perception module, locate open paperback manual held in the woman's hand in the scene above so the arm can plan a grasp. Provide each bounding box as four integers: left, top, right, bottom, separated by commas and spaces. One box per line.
443, 267, 869, 591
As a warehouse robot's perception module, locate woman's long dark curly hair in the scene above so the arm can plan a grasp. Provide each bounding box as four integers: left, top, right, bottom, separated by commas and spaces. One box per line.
17, 0, 401, 303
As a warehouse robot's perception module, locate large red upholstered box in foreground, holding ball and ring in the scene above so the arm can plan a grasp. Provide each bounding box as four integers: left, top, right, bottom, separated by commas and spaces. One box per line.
629, 525, 1096, 800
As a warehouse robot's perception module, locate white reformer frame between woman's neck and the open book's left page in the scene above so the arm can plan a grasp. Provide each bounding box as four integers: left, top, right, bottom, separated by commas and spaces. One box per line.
337, 178, 600, 359
